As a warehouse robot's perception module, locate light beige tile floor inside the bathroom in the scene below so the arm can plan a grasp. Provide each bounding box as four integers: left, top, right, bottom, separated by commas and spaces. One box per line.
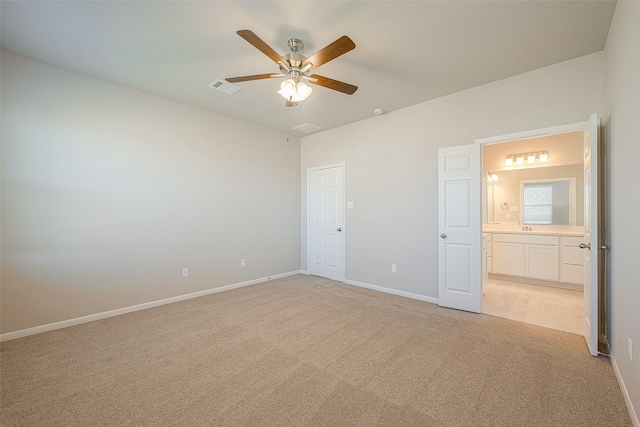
482, 279, 584, 335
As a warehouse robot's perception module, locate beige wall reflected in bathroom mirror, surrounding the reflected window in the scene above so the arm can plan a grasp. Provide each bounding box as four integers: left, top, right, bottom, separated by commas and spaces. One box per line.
489, 164, 584, 225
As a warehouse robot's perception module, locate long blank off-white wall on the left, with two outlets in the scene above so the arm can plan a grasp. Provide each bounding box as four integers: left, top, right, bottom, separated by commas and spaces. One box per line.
1, 52, 300, 333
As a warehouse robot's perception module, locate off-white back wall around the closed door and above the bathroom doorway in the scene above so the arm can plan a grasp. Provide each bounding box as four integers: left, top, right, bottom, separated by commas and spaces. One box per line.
301, 53, 604, 298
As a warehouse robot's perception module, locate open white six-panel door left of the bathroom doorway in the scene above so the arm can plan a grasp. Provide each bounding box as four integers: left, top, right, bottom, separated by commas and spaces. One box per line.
438, 144, 482, 313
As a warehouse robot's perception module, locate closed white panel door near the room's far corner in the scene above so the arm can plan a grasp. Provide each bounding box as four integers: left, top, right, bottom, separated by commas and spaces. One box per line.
307, 166, 344, 281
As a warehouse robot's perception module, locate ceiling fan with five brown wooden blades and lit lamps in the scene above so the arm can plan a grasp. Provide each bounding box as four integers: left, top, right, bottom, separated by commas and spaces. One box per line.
225, 30, 358, 107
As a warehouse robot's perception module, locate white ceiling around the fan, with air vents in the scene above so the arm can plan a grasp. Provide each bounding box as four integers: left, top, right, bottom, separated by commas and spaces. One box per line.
0, 0, 615, 136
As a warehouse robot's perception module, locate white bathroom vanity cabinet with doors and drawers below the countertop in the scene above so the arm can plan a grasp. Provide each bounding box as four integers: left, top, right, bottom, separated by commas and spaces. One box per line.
488, 232, 584, 290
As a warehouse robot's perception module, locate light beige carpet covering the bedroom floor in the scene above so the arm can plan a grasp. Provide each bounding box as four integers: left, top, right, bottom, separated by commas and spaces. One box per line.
0, 275, 631, 427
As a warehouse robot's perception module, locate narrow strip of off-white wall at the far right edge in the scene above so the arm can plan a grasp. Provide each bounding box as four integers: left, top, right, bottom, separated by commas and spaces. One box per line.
603, 1, 640, 425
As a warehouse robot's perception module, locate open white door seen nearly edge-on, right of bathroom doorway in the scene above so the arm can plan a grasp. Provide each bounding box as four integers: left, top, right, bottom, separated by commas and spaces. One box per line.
580, 114, 599, 356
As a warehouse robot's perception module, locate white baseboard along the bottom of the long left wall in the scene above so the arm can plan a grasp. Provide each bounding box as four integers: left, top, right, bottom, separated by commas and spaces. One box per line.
0, 270, 300, 342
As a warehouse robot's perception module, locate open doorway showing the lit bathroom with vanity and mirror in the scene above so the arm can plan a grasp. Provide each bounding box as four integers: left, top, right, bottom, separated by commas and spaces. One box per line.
481, 129, 585, 335
